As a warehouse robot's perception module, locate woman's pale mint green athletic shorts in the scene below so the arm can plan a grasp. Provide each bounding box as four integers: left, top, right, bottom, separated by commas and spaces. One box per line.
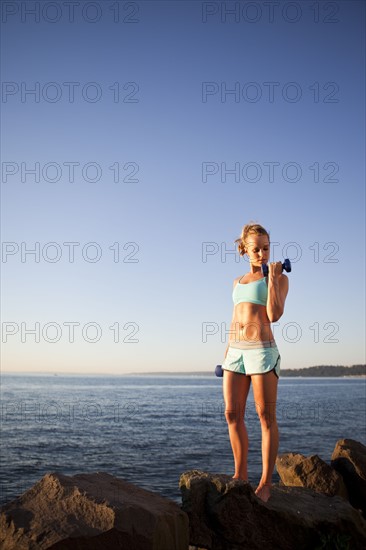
222, 340, 281, 378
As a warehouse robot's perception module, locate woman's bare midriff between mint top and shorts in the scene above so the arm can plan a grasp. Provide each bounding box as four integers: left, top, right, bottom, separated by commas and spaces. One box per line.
229, 302, 274, 344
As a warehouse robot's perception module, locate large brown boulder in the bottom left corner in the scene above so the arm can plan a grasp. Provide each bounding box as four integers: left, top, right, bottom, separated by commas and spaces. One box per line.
0, 473, 189, 550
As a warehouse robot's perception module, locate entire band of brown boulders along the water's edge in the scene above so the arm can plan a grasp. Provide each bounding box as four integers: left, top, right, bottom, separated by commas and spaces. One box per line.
0, 439, 366, 550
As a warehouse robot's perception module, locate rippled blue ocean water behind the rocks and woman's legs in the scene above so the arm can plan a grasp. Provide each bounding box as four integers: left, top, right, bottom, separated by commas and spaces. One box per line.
0, 374, 366, 504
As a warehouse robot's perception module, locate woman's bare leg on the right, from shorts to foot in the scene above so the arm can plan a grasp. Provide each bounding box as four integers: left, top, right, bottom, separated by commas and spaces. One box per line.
251, 371, 279, 502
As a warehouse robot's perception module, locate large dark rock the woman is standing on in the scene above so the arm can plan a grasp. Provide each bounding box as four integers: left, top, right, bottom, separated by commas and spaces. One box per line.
179, 470, 366, 550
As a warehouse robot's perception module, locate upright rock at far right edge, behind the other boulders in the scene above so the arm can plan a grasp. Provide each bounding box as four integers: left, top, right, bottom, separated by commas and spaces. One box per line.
331, 439, 366, 518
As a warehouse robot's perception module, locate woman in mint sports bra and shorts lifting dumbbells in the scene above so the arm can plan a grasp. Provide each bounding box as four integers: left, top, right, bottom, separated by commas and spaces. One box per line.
222, 223, 288, 502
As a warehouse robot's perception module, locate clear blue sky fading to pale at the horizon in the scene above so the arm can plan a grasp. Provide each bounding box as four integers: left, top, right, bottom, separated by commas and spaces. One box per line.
1, 1, 365, 374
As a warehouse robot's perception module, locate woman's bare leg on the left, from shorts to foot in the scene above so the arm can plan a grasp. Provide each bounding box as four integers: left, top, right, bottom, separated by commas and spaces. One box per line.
223, 370, 250, 481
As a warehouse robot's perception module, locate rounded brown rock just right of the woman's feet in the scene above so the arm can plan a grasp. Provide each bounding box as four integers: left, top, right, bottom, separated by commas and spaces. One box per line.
276, 453, 348, 499
